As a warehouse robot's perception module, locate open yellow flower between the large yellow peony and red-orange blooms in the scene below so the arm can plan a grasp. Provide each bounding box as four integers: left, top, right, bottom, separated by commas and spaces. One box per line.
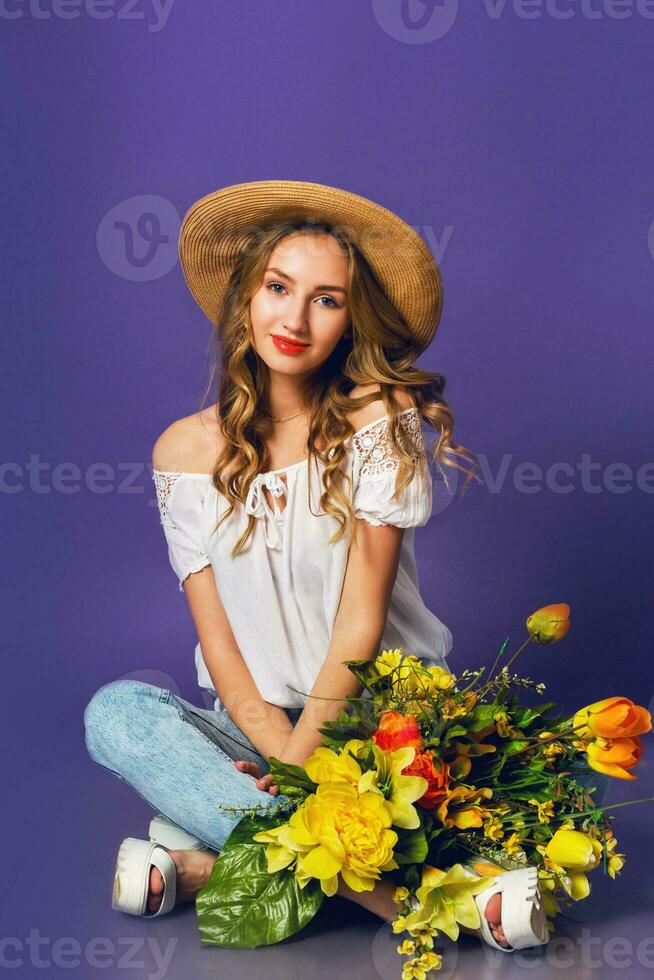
358, 742, 429, 830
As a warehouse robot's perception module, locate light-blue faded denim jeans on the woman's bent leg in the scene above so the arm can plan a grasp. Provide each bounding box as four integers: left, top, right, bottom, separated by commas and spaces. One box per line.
84, 680, 302, 851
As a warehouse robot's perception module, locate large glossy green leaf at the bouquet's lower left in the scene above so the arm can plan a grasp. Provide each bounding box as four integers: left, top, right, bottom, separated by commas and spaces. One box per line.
195, 817, 324, 949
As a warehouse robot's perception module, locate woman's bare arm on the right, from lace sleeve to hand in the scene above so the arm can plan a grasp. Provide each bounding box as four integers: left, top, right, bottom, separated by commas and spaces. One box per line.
279, 520, 404, 765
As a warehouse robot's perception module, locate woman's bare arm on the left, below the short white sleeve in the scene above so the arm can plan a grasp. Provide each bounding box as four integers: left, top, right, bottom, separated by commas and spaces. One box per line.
178, 565, 293, 759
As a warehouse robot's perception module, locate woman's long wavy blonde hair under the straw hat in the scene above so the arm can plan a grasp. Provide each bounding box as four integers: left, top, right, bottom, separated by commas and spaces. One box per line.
200, 219, 477, 558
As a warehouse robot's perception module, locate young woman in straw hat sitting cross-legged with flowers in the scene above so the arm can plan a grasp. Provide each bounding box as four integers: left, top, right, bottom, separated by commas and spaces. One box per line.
85, 181, 568, 949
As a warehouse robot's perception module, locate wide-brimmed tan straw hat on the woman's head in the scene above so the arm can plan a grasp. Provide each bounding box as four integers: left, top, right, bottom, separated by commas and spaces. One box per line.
179, 180, 443, 351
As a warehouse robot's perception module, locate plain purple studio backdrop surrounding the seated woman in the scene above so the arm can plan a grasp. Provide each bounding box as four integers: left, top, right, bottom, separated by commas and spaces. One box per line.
6, 0, 654, 978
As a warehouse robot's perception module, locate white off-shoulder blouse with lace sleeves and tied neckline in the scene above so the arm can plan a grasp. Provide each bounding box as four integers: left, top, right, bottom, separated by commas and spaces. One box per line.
152, 407, 452, 709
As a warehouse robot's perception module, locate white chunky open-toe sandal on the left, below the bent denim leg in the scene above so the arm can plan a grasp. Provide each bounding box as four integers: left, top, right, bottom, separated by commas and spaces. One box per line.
111, 814, 207, 919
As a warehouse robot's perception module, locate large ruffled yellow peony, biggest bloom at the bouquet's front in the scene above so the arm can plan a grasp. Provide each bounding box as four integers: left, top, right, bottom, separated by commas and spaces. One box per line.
254, 782, 399, 896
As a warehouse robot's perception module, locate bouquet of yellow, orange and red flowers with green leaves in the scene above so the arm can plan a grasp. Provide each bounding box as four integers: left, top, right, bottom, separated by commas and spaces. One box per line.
196, 603, 652, 980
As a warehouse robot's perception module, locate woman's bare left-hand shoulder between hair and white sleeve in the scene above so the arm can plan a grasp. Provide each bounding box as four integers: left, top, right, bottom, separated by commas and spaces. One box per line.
152, 404, 222, 473
